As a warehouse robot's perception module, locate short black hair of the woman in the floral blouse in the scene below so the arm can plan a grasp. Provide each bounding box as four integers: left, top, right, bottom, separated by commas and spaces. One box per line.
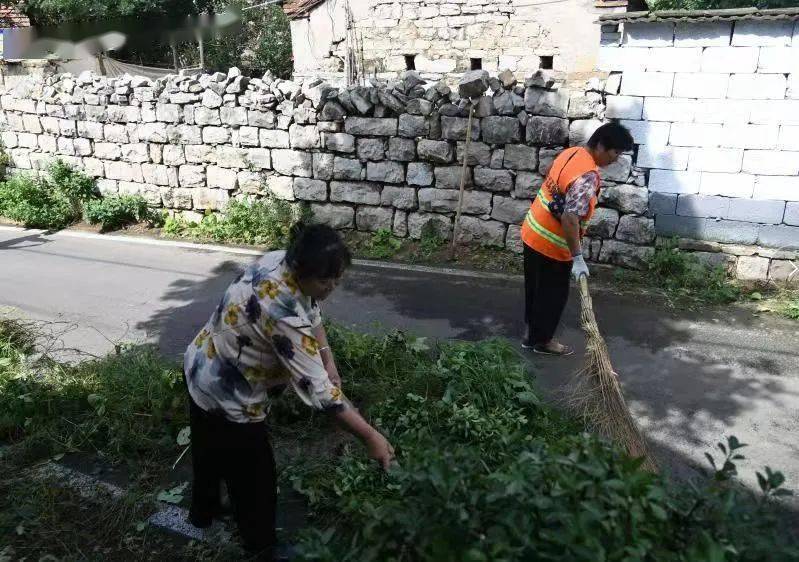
286, 222, 352, 279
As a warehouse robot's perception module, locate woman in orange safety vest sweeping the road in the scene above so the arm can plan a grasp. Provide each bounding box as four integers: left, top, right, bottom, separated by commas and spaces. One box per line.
522, 123, 633, 356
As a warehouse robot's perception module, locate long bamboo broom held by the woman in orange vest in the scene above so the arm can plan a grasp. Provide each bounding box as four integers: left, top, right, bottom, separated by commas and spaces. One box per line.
569, 275, 657, 472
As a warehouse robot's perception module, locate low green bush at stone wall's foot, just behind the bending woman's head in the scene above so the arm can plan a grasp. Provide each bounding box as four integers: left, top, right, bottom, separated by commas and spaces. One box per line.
163, 197, 310, 248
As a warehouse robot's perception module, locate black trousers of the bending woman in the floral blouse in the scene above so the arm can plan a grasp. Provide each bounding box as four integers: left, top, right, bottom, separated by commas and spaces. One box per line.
189, 398, 277, 552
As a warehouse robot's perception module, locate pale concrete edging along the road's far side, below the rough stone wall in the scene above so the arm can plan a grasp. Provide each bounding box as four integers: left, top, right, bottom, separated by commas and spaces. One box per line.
0, 225, 524, 282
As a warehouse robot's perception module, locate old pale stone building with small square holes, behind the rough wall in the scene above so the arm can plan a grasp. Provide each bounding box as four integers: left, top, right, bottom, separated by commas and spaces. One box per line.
284, 0, 628, 84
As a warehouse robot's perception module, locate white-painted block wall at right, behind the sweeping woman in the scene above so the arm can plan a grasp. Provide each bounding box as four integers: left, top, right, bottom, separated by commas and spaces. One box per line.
599, 21, 799, 280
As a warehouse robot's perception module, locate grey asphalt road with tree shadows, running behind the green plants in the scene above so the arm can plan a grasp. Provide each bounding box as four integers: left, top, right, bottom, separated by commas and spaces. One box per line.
0, 225, 799, 500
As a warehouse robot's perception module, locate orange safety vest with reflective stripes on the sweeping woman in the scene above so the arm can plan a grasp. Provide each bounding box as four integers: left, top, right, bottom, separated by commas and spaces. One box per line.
522, 146, 599, 261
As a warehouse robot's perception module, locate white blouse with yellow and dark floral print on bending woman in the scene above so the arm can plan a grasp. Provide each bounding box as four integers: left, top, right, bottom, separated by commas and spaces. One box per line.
184, 251, 347, 423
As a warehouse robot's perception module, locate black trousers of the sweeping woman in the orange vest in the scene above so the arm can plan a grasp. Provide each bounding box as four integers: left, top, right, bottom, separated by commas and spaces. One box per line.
524, 244, 572, 345
